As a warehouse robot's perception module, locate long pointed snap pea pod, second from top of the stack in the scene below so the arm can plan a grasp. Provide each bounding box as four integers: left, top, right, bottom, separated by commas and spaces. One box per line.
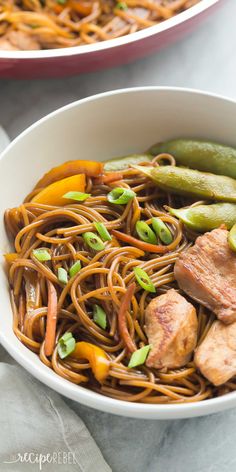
133, 166, 236, 202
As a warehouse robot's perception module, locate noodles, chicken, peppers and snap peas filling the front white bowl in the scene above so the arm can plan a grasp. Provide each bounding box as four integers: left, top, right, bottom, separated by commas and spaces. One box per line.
5, 139, 236, 404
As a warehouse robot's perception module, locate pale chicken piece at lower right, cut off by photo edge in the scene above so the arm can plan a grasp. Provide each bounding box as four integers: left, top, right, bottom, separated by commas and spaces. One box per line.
194, 321, 236, 386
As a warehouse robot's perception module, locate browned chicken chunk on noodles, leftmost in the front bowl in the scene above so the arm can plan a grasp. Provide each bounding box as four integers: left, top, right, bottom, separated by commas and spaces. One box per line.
145, 289, 198, 369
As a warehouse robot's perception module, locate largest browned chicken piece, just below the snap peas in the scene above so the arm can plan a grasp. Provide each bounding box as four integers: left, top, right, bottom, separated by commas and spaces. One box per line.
174, 228, 236, 324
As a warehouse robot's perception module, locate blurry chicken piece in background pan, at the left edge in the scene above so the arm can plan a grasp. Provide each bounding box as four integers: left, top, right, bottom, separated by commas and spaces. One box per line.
0, 30, 40, 51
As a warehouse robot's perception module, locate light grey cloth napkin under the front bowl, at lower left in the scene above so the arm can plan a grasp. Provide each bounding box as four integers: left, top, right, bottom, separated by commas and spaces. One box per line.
0, 126, 111, 472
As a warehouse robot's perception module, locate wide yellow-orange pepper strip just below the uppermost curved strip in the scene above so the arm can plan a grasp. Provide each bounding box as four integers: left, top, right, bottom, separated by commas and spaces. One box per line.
31, 174, 85, 206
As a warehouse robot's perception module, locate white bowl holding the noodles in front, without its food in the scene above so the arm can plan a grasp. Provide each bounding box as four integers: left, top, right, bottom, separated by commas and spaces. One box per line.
0, 87, 236, 419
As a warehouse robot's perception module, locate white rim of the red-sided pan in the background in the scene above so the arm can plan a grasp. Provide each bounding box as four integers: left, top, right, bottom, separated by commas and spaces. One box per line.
0, 0, 219, 60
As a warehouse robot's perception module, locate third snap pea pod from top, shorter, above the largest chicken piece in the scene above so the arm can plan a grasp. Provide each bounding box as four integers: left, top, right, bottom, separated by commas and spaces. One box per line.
169, 203, 236, 233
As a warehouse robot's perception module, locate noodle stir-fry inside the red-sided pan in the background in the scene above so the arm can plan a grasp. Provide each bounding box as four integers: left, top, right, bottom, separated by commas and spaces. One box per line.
0, 0, 199, 51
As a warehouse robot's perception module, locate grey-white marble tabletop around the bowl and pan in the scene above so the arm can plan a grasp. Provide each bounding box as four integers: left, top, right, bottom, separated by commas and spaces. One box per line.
0, 0, 236, 472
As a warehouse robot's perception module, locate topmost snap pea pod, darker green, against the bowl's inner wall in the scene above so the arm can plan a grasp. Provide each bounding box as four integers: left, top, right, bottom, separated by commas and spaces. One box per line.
148, 139, 236, 179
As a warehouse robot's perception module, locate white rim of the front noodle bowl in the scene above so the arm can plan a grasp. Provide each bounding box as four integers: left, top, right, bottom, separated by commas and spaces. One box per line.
0, 86, 236, 419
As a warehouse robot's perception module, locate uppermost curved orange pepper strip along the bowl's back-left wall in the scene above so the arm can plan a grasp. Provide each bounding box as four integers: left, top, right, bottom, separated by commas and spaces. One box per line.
35, 161, 103, 188
